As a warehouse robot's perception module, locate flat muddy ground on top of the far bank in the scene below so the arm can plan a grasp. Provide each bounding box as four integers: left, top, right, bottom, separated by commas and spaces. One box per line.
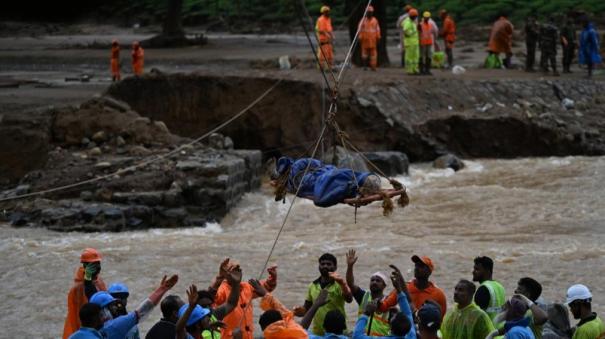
0, 25, 604, 113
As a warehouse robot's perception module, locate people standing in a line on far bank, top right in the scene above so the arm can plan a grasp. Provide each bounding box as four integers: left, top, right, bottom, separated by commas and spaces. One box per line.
315, 5, 602, 77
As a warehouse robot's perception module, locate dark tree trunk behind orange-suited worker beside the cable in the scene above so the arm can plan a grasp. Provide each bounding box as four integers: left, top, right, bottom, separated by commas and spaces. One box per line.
345, 0, 389, 66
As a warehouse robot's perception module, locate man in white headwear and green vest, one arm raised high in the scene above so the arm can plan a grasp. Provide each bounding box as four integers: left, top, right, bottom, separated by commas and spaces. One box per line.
347, 250, 396, 337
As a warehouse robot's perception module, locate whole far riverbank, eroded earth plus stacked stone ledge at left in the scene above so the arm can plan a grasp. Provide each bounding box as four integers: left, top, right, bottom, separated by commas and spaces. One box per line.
0, 73, 605, 231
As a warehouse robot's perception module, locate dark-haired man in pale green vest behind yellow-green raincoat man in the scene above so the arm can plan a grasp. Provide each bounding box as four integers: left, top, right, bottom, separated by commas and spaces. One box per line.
473, 257, 506, 327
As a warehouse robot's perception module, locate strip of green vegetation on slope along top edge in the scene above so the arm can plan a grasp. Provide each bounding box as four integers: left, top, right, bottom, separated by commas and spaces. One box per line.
105, 0, 605, 31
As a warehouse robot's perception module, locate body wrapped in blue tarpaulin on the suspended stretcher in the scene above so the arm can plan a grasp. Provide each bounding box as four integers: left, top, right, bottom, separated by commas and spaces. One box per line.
272, 157, 380, 207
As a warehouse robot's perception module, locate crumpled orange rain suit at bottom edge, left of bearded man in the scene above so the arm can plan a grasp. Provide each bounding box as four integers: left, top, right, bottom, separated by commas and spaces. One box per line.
260, 293, 309, 339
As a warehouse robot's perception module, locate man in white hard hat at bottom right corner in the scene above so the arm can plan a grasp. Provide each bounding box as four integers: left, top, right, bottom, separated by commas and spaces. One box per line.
567, 284, 605, 339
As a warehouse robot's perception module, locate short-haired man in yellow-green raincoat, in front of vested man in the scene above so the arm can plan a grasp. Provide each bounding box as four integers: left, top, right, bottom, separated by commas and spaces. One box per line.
441, 280, 494, 339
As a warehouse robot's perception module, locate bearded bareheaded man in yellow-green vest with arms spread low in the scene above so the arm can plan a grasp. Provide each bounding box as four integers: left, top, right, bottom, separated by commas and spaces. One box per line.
294, 253, 353, 335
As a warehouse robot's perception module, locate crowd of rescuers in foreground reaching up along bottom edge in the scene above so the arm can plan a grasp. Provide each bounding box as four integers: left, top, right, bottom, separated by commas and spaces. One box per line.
63, 248, 605, 339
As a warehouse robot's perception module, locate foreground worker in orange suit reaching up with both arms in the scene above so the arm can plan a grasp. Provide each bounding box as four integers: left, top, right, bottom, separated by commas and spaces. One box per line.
211, 259, 277, 339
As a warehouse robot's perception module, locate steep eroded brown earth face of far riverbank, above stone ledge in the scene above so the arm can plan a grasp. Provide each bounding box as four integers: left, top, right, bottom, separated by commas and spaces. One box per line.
108, 74, 605, 161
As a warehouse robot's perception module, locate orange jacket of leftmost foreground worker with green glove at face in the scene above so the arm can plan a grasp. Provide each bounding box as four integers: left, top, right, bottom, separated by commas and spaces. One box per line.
63, 266, 107, 339
